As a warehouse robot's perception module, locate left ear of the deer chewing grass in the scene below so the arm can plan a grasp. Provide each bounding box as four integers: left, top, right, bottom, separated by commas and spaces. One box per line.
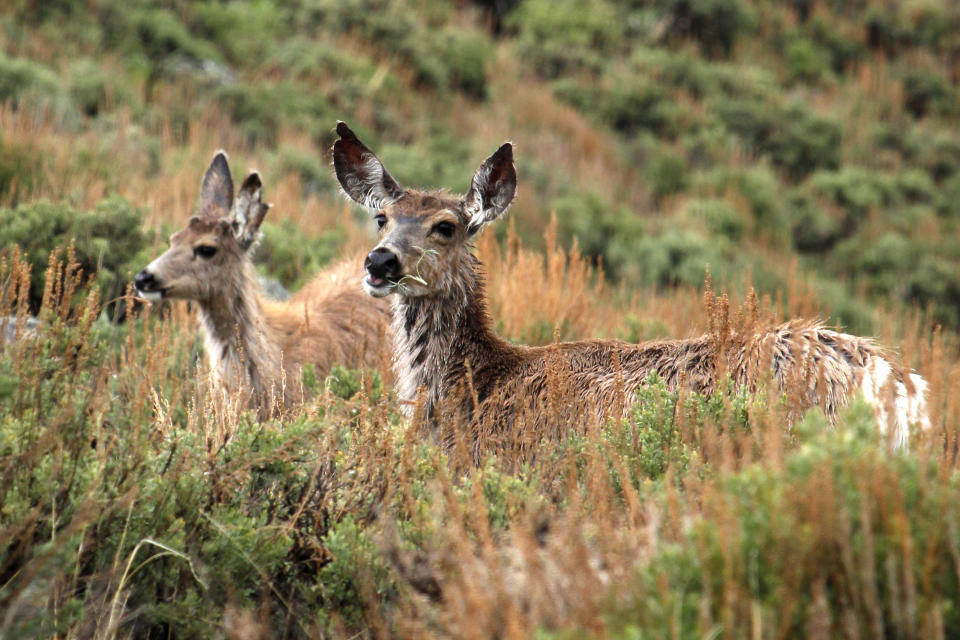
333, 122, 403, 211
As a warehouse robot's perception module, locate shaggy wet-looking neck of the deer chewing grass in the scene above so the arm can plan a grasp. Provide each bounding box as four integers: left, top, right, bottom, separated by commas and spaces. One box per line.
393, 254, 505, 416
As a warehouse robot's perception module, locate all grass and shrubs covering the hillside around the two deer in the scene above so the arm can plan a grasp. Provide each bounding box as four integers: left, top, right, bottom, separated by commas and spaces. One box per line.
0, 0, 960, 639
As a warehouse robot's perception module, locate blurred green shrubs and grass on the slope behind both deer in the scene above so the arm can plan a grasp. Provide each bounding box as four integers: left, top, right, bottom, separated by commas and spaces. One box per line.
0, 0, 960, 331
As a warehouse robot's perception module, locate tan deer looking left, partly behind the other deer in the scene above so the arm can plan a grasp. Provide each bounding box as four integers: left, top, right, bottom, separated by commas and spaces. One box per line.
134, 151, 391, 418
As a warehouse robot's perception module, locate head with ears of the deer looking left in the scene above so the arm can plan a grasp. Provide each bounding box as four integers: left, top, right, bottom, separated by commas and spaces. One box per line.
134, 151, 270, 301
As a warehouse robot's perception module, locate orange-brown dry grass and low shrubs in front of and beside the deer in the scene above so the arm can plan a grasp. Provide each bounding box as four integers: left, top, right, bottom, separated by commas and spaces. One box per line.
0, 214, 960, 638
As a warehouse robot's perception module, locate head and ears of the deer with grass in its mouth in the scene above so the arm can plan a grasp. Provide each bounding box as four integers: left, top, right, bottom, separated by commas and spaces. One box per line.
333, 122, 517, 297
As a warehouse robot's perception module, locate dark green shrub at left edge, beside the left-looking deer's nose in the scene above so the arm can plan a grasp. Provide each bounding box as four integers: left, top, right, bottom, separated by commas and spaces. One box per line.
0, 196, 148, 317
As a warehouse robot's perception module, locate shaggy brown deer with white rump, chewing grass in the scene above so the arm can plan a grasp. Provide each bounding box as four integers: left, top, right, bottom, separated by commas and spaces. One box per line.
333, 122, 929, 462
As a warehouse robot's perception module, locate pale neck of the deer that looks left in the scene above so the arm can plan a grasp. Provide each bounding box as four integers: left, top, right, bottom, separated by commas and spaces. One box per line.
199, 264, 281, 401
